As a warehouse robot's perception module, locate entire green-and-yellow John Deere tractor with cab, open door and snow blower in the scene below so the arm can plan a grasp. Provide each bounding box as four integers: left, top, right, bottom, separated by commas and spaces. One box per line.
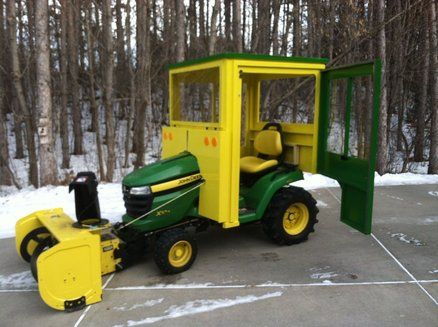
16, 54, 380, 310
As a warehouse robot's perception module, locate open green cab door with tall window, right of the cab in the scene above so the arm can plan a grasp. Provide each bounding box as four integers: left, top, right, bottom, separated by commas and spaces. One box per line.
317, 60, 381, 234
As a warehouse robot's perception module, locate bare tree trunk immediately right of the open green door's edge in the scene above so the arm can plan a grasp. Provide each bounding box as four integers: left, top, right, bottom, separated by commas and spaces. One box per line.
376, 0, 388, 175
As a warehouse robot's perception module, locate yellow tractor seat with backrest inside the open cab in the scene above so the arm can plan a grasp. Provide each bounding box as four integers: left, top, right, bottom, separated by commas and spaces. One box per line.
240, 126, 283, 174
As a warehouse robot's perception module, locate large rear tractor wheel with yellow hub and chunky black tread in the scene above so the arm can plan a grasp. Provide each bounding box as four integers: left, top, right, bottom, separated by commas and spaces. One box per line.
262, 187, 319, 245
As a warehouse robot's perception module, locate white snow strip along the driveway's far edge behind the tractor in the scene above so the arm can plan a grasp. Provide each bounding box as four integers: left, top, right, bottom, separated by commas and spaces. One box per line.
0, 173, 438, 238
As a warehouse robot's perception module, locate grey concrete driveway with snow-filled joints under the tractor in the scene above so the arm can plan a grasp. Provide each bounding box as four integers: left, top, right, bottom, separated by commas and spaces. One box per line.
0, 185, 438, 326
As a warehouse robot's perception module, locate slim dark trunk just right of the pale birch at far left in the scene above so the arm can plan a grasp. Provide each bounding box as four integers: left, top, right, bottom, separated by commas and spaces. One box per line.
59, 0, 70, 168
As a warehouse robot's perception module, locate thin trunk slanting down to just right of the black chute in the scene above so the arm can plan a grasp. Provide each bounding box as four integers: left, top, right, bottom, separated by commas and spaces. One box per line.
85, 2, 106, 180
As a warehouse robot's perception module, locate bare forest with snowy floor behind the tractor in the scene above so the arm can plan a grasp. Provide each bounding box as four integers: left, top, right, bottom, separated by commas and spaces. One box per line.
0, 0, 438, 188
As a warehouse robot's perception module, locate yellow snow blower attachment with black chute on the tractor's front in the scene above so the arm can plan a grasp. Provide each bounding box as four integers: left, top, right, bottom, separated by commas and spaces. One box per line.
15, 175, 121, 311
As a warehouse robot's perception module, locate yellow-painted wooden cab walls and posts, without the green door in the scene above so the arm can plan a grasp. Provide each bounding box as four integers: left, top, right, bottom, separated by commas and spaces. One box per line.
163, 59, 325, 228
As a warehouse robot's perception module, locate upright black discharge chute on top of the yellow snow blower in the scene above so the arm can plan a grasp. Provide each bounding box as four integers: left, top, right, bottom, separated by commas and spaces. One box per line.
69, 171, 102, 225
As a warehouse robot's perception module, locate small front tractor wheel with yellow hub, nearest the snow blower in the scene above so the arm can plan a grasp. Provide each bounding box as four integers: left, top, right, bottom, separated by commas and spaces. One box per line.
154, 228, 198, 274
